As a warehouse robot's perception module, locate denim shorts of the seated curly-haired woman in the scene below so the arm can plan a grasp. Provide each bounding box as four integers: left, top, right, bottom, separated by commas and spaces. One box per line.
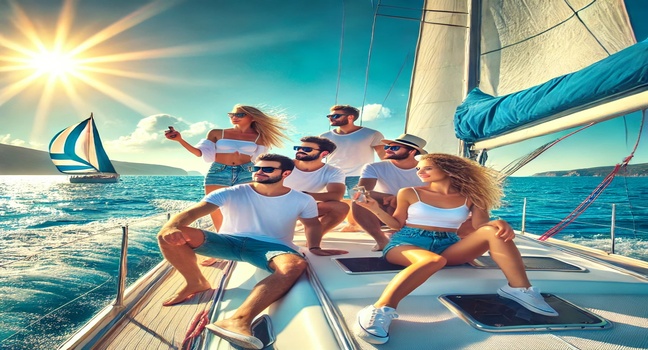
383, 226, 460, 256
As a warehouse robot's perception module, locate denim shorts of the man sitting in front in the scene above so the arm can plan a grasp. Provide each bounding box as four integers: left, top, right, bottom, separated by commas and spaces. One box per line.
194, 230, 303, 272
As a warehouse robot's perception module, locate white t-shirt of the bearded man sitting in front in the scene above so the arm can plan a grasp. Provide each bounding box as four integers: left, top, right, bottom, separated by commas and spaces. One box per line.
203, 184, 317, 250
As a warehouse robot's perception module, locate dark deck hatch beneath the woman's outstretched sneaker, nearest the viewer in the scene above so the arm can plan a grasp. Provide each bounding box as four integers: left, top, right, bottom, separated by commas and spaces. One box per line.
439, 293, 612, 332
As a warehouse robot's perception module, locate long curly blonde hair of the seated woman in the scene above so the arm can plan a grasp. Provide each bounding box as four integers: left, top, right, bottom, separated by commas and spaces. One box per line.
419, 153, 504, 211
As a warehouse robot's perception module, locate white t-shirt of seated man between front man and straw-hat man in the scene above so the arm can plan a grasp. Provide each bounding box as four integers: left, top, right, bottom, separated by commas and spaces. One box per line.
284, 164, 345, 193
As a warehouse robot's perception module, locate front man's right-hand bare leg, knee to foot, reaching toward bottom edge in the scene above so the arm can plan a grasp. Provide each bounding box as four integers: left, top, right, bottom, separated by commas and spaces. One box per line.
210, 254, 307, 335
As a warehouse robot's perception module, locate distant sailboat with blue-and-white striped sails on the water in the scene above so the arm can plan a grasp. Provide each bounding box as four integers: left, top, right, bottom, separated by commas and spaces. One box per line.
49, 114, 119, 183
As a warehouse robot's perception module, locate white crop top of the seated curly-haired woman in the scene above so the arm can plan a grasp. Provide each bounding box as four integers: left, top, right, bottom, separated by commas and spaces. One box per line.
405, 187, 470, 229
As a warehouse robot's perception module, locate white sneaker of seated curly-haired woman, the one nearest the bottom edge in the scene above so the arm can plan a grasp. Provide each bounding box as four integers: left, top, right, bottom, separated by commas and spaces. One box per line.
356, 305, 398, 344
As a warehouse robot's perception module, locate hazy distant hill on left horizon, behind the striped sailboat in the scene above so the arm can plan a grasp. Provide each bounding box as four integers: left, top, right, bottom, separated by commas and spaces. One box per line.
0, 144, 187, 176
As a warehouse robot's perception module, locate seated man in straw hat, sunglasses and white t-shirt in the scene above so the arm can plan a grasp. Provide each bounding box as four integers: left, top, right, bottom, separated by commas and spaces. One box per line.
352, 134, 427, 250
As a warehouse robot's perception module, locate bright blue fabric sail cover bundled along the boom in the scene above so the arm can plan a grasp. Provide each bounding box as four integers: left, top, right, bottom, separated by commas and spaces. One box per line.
454, 40, 648, 142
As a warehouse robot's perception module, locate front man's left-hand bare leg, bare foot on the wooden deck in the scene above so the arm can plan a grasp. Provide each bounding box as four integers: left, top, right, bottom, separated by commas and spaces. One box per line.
158, 227, 211, 306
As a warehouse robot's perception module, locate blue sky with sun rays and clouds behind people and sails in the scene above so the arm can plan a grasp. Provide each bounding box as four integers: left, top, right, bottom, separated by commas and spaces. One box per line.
0, 0, 648, 175
